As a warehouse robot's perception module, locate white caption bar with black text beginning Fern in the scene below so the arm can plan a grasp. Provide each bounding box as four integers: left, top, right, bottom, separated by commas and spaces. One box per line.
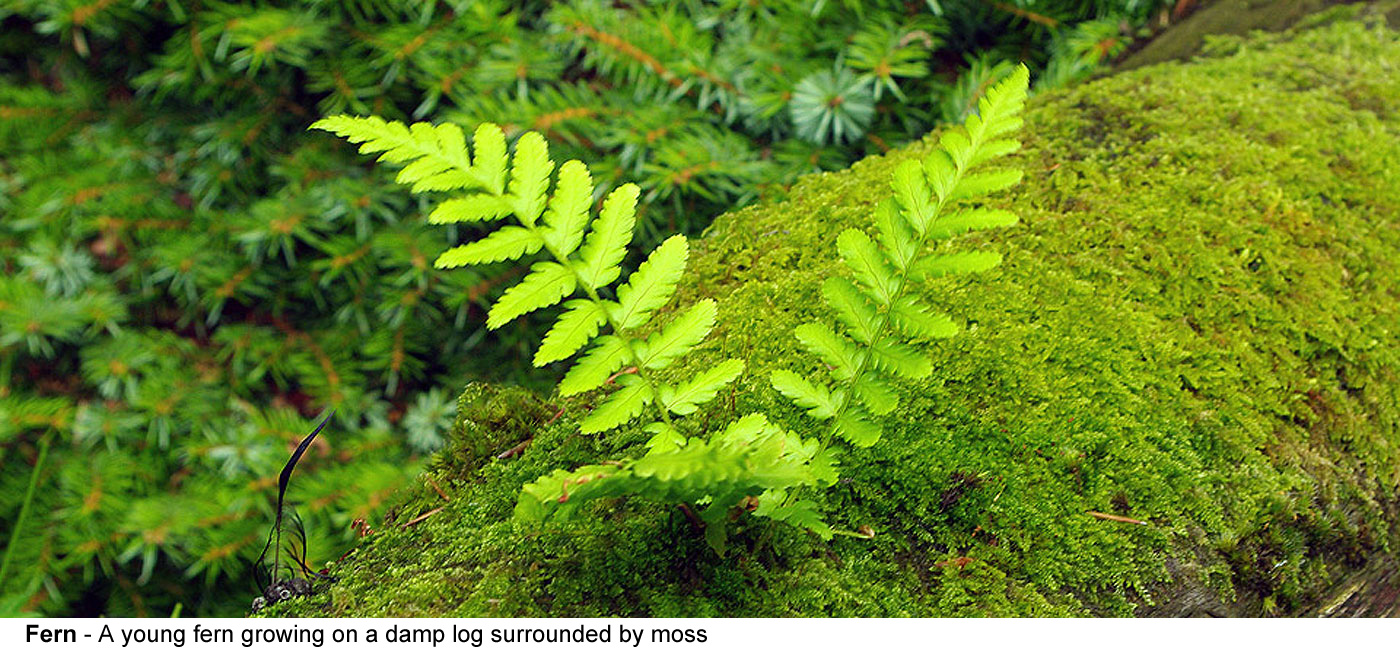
0, 619, 1400, 650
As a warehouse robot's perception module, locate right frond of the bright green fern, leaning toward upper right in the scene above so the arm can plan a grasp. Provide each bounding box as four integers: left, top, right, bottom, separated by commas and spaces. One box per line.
771, 66, 1029, 447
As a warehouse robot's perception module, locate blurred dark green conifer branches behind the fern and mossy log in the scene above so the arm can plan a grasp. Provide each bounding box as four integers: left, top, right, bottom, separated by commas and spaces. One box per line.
0, 0, 1170, 616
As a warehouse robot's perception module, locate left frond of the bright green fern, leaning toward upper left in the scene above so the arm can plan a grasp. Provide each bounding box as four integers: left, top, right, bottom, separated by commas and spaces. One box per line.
312, 115, 742, 433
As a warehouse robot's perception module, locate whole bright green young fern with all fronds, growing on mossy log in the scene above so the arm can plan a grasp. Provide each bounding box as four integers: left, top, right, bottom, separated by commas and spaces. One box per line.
314, 67, 1028, 555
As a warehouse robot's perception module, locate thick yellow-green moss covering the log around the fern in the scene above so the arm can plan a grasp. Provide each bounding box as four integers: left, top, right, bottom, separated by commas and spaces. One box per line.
274, 22, 1400, 616
